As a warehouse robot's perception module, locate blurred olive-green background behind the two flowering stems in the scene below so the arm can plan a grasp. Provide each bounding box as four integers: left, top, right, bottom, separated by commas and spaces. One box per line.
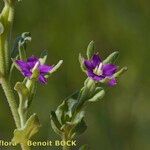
0, 0, 150, 150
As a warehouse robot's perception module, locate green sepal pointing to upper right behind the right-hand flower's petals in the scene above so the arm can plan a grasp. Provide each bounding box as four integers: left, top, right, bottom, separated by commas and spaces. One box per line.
103, 51, 119, 64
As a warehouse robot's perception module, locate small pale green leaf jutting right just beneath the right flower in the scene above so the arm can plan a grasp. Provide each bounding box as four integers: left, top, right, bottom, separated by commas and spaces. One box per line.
88, 88, 105, 102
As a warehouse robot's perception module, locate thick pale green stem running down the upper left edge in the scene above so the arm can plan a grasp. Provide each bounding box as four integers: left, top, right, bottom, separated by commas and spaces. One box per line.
0, 0, 14, 77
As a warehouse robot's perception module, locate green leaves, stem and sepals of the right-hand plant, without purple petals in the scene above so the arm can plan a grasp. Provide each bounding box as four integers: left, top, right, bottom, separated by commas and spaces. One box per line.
51, 41, 126, 150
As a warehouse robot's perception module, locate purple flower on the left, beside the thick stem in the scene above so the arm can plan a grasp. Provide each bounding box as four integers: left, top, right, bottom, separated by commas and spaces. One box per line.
15, 56, 53, 84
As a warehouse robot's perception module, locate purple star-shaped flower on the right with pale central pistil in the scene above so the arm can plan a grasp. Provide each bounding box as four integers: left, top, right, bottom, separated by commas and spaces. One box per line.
84, 54, 118, 86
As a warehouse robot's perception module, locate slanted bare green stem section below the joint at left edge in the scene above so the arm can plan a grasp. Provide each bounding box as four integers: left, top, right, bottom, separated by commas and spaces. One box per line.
1, 78, 20, 128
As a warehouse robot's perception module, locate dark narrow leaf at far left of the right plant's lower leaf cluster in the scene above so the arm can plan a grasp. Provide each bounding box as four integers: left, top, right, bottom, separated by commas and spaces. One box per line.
51, 111, 62, 135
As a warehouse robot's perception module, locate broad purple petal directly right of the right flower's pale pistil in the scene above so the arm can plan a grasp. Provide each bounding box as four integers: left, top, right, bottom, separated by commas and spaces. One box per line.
103, 64, 118, 76
